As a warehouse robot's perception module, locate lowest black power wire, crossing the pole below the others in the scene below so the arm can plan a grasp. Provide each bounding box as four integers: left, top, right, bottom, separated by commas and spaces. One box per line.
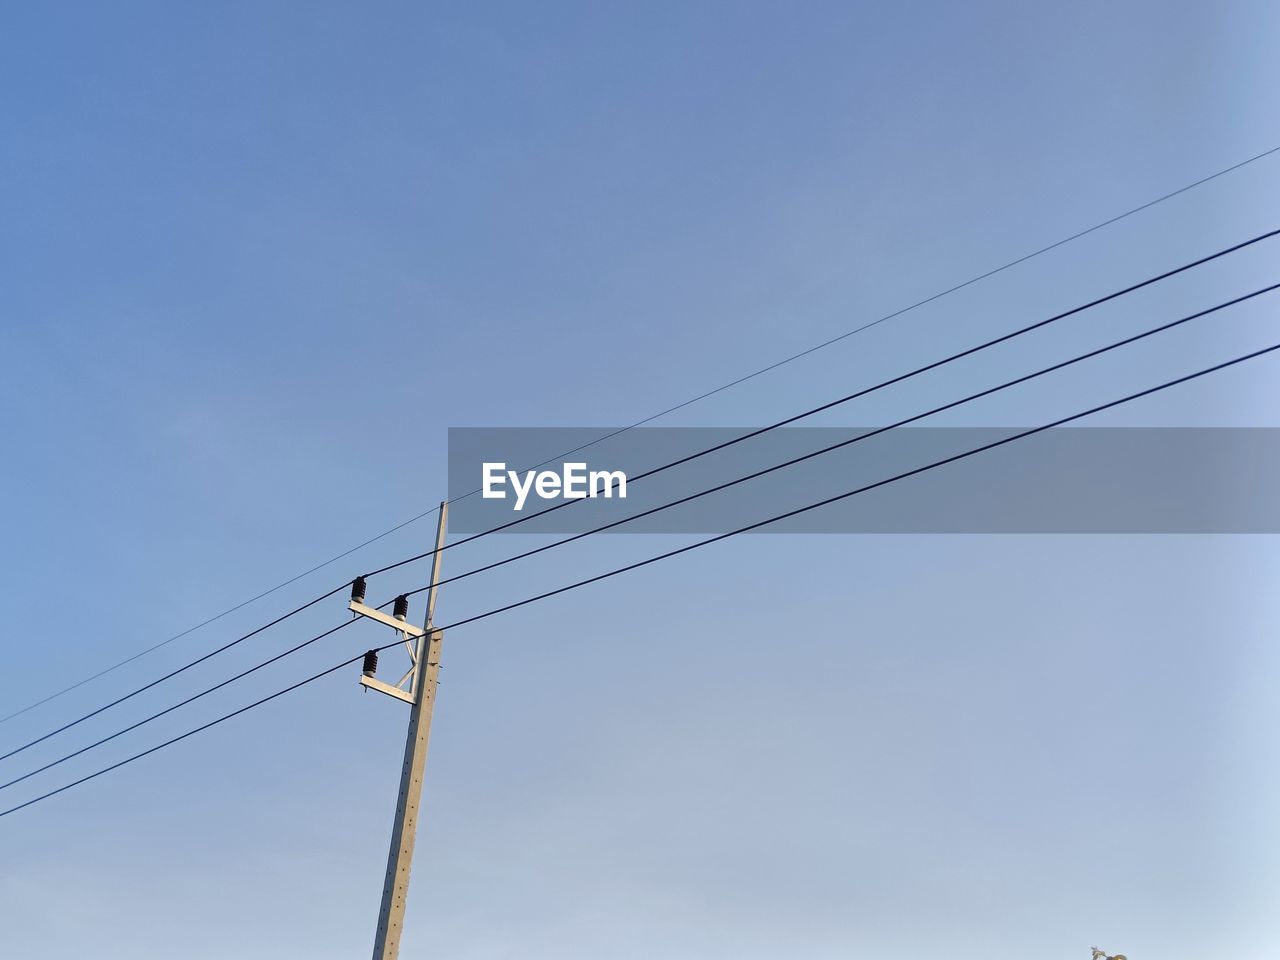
0, 343, 1280, 817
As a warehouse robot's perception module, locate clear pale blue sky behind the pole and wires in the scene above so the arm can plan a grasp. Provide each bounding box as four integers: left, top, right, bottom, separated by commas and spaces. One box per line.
0, 0, 1280, 960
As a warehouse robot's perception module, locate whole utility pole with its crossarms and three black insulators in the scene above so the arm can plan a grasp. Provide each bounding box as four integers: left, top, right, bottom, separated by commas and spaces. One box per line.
349, 500, 449, 960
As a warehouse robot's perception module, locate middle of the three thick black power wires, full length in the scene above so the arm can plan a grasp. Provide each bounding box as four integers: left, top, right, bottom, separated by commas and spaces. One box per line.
15, 283, 1280, 790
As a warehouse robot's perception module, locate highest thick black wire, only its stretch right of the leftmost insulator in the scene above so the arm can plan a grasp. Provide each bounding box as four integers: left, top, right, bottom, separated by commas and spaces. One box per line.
365, 229, 1280, 577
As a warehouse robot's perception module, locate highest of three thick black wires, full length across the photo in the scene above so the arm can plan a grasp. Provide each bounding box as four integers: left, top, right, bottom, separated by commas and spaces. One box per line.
0, 229, 1280, 760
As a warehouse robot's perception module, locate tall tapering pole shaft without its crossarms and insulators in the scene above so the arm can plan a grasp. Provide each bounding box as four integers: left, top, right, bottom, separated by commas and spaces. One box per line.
374, 500, 449, 960
